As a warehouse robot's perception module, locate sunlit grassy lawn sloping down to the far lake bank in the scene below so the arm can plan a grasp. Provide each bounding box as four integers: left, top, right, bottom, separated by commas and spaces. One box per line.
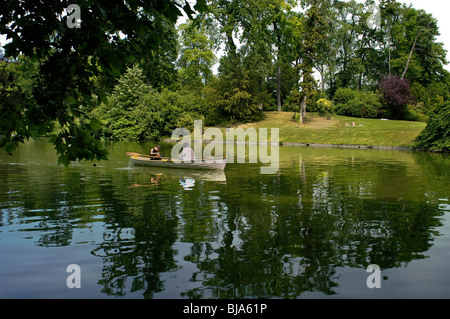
239, 112, 426, 147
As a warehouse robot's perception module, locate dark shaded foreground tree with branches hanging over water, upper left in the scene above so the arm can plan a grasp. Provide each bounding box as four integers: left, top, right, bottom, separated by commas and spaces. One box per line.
0, 0, 205, 165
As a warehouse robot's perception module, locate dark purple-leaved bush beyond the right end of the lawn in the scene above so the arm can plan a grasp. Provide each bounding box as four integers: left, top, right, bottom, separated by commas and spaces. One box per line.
379, 75, 412, 120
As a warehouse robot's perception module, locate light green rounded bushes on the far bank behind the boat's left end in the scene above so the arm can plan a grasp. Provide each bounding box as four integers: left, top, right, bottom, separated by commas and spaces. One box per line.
90, 66, 207, 140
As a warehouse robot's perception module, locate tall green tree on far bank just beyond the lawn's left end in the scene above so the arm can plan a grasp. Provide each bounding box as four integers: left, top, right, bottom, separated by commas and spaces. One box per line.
204, 0, 273, 121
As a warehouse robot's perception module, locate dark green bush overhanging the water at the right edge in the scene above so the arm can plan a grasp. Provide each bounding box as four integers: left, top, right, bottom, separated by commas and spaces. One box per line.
414, 101, 450, 152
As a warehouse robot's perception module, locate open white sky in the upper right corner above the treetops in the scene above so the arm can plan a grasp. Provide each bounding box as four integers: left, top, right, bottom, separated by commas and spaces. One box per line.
0, 0, 450, 71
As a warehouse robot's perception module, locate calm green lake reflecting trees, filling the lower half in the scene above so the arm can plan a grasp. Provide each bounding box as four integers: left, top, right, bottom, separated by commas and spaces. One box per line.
0, 140, 450, 299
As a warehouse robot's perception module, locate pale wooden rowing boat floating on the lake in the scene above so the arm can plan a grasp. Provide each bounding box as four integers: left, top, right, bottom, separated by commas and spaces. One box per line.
127, 152, 227, 170
